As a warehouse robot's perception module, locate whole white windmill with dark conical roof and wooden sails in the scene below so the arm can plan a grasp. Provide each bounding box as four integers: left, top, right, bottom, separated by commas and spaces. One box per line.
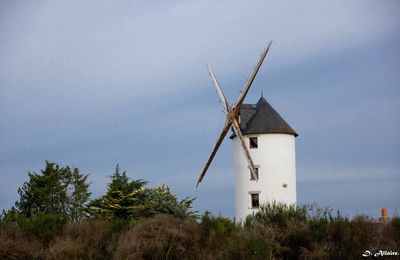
196, 42, 297, 222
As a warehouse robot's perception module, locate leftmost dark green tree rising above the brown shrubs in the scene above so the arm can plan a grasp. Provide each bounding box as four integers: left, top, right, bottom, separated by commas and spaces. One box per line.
15, 161, 90, 221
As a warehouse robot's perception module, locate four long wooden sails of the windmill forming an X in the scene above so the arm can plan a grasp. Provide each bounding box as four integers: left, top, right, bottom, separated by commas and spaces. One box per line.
196, 41, 272, 187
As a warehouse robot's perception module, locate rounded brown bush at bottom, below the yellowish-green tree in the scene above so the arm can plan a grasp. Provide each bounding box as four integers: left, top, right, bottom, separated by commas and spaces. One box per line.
115, 215, 202, 259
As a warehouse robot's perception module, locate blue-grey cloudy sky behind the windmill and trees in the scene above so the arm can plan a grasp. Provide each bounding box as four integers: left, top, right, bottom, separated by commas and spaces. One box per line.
0, 0, 400, 216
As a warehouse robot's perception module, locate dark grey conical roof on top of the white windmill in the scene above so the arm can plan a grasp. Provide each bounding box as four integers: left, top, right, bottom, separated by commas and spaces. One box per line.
231, 97, 298, 138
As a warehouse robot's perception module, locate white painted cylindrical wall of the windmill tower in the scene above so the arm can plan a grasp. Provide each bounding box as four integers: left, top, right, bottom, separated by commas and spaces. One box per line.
233, 134, 296, 222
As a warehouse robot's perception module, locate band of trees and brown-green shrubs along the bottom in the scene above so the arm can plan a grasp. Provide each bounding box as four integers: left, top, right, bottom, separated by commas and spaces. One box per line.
0, 162, 400, 259
